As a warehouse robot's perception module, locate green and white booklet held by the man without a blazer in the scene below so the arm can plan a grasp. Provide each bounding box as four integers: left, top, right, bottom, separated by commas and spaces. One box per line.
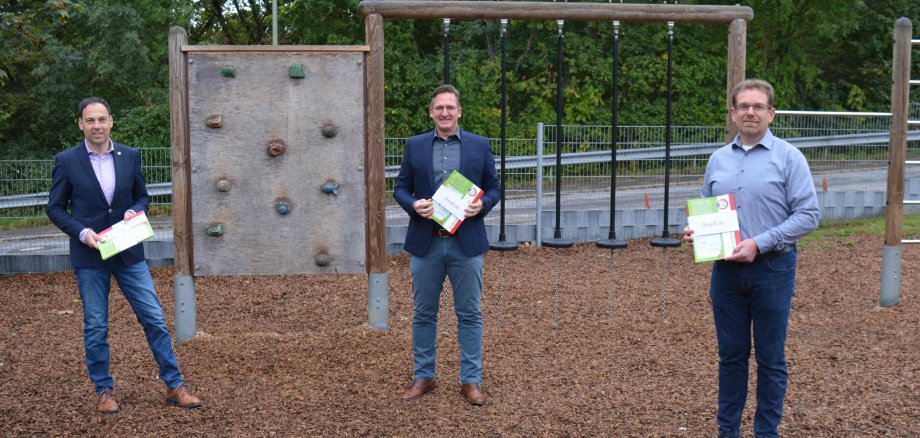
687, 193, 741, 262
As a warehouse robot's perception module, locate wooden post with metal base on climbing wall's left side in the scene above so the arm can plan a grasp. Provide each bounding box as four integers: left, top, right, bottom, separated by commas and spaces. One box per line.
169, 26, 197, 343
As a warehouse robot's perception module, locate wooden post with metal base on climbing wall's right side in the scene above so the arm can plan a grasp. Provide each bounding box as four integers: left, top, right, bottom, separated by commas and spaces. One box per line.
364, 14, 389, 330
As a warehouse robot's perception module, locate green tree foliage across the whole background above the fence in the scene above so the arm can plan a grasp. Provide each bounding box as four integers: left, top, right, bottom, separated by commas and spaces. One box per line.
0, 0, 920, 158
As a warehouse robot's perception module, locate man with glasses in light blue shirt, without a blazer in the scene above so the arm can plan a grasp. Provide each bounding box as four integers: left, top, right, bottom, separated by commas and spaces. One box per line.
684, 79, 819, 438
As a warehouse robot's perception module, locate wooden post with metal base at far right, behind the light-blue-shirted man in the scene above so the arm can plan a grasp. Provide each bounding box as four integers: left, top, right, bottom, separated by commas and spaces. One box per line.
879, 17, 913, 307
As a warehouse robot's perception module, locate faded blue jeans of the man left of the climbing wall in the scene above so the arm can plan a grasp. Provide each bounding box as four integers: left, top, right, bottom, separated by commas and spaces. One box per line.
74, 261, 182, 393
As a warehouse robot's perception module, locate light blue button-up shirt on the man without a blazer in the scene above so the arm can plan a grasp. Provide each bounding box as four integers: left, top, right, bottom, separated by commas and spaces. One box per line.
700, 129, 820, 253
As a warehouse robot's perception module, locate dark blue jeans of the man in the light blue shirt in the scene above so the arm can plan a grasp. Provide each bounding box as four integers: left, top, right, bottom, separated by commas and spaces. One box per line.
709, 251, 797, 437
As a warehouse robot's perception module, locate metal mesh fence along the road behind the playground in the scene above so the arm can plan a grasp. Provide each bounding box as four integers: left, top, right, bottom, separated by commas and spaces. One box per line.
0, 111, 920, 254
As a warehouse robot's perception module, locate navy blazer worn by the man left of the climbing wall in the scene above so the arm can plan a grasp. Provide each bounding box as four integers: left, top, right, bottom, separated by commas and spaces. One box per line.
47, 141, 150, 268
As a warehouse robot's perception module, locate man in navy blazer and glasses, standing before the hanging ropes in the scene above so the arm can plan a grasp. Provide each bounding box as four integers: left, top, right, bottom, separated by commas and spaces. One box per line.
393, 85, 501, 405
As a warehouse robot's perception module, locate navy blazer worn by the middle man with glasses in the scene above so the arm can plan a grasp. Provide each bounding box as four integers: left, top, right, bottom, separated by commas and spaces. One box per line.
393, 131, 501, 257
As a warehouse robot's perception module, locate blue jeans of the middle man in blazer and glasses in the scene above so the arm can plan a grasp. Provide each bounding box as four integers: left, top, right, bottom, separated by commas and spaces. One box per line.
409, 237, 482, 384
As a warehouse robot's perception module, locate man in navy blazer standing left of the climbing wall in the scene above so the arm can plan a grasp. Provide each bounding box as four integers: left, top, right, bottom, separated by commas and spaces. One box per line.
47, 97, 201, 414
